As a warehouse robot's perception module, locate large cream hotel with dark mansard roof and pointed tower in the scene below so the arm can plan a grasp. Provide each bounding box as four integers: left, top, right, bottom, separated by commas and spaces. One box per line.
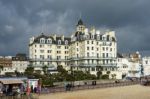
29, 19, 117, 74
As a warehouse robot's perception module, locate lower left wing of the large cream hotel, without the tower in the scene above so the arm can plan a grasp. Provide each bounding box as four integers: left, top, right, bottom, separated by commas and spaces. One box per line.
29, 33, 70, 70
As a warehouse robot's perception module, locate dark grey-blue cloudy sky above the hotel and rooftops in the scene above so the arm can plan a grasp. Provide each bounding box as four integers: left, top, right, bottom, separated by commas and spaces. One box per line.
0, 0, 150, 55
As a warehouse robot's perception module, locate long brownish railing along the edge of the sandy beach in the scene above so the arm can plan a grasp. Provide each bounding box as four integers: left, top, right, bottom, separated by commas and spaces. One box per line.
41, 81, 139, 94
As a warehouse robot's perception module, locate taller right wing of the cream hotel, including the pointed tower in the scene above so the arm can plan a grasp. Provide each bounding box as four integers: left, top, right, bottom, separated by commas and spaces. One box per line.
69, 20, 117, 74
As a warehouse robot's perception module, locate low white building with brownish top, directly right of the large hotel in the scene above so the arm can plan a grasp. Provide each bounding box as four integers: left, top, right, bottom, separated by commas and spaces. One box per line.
117, 52, 142, 78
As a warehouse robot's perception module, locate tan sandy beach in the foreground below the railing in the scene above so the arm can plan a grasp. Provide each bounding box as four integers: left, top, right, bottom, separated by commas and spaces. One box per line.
39, 85, 150, 99
